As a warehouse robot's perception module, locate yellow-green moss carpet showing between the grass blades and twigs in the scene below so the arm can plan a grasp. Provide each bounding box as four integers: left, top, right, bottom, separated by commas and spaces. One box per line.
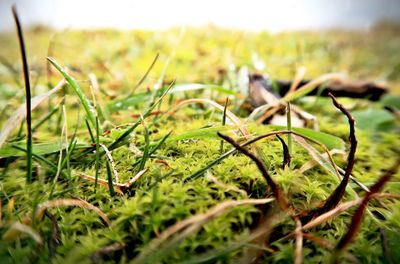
0, 25, 400, 263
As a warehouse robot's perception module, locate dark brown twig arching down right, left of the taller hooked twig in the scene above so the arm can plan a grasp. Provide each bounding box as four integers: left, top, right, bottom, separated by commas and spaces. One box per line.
217, 132, 289, 211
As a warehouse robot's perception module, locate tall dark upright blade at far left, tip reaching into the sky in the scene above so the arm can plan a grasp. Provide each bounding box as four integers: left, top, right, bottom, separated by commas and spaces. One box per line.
12, 5, 32, 183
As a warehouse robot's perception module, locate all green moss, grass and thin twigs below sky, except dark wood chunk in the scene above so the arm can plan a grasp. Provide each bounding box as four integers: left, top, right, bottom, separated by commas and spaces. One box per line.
0, 15, 400, 263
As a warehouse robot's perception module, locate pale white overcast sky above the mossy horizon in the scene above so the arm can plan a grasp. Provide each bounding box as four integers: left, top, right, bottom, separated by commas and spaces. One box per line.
0, 0, 400, 32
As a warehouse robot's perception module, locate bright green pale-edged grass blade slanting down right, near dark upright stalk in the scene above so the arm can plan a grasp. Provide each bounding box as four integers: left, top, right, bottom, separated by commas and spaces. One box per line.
47, 58, 97, 127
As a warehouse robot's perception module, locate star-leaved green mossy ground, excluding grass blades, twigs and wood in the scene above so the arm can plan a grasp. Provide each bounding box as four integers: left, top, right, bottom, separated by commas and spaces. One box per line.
0, 24, 400, 263
